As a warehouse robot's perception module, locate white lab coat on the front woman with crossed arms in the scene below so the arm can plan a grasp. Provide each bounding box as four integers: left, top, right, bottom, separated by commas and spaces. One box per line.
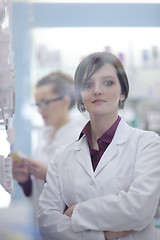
38, 120, 160, 240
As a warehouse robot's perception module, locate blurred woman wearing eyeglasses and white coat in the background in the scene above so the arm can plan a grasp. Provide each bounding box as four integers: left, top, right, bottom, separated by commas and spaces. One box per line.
13, 72, 80, 240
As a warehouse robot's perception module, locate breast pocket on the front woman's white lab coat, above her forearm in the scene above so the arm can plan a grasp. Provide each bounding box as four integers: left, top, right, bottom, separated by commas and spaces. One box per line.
112, 176, 132, 195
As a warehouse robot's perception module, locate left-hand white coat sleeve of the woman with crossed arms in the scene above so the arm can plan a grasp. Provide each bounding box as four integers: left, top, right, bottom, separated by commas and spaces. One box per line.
37, 150, 104, 240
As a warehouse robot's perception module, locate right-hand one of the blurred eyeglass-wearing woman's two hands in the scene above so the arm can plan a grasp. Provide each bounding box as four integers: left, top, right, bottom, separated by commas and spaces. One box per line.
26, 158, 48, 181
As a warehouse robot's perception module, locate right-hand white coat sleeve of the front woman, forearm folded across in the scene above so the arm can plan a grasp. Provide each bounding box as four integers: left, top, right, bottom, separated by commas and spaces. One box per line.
71, 132, 160, 232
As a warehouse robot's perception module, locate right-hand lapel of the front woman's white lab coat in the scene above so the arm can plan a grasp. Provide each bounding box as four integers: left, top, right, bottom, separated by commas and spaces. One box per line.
95, 119, 131, 176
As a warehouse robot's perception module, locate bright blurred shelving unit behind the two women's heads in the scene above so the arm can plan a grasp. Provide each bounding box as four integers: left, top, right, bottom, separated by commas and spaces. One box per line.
31, 27, 160, 137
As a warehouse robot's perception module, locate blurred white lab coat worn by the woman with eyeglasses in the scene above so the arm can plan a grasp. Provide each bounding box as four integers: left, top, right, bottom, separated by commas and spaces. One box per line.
30, 121, 81, 233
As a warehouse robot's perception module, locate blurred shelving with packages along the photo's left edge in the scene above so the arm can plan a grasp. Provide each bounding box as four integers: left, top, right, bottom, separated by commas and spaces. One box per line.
0, 0, 15, 193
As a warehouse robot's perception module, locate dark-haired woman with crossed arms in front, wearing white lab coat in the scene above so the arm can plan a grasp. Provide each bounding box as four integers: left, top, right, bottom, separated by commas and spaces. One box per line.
38, 52, 160, 240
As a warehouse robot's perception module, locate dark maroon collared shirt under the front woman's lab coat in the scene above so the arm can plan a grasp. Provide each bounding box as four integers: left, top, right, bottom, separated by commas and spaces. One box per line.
80, 116, 121, 171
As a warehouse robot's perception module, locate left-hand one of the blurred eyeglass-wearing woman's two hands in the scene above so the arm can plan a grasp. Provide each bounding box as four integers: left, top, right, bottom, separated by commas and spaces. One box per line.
12, 159, 30, 183
